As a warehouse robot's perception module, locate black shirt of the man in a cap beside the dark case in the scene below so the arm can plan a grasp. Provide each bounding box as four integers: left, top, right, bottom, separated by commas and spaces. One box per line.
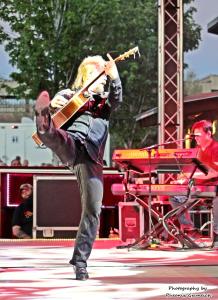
12, 197, 33, 236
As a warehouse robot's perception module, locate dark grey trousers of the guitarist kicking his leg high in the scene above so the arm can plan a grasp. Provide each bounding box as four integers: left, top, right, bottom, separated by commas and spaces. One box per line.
38, 122, 103, 267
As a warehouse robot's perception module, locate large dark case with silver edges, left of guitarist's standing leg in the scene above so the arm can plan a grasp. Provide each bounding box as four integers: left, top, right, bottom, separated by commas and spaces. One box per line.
33, 176, 81, 238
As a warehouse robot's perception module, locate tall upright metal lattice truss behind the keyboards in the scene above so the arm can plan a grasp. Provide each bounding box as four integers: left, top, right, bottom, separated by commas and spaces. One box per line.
158, 0, 183, 181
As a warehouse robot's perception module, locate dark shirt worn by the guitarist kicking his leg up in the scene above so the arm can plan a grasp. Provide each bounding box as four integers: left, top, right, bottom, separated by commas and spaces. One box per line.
58, 78, 122, 165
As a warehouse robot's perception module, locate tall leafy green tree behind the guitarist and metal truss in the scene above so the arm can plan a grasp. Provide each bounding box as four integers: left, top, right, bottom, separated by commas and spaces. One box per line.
0, 0, 200, 148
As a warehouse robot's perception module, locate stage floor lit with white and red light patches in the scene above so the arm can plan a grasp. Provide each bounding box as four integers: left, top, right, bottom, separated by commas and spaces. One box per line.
0, 239, 218, 300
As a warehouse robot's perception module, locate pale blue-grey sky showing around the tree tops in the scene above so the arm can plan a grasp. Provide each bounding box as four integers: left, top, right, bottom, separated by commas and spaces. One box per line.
0, 0, 218, 79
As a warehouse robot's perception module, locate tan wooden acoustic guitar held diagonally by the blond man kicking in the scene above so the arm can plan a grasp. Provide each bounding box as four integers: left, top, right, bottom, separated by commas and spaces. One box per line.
32, 47, 139, 146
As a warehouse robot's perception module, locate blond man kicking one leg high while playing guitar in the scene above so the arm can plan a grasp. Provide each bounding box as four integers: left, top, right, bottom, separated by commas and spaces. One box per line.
35, 55, 122, 280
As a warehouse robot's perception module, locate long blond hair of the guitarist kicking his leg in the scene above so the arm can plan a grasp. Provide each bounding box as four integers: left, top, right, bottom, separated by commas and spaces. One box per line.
71, 55, 105, 90
